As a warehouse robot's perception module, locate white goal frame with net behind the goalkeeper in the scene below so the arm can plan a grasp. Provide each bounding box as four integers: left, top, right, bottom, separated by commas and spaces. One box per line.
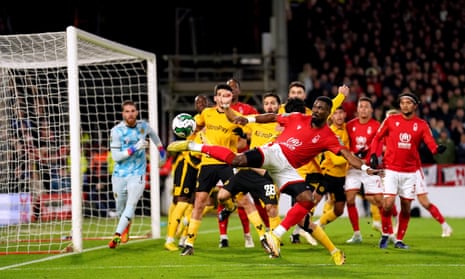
0, 27, 160, 254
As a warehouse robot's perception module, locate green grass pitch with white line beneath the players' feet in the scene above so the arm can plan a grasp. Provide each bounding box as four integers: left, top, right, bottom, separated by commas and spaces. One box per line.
0, 215, 465, 279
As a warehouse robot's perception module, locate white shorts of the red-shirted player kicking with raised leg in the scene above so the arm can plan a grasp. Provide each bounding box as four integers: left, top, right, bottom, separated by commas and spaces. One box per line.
259, 144, 305, 190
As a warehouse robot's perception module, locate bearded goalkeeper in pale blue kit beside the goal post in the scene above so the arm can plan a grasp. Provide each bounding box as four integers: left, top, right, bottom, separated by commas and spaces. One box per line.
108, 101, 166, 248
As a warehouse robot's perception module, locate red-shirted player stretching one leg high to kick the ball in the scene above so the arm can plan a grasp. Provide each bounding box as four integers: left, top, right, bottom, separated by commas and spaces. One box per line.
168, 86, 381, 265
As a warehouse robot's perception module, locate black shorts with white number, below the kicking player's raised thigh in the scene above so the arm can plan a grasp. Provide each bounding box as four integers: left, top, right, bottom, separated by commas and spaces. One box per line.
223, 169, 279, 204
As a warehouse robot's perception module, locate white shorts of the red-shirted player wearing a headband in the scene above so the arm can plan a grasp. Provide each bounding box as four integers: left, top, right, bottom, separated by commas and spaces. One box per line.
383, 170, 418, 200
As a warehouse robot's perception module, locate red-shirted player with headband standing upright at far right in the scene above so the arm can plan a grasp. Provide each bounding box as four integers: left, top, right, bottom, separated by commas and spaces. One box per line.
370, 92, 445, 249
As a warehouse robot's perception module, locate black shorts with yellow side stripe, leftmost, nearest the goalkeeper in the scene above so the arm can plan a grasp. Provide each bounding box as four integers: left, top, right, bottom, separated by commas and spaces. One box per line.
173, 157, 198, 199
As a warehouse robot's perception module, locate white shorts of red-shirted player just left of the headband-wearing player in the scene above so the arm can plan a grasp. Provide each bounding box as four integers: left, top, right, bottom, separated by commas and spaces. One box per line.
344, 168, 383, 195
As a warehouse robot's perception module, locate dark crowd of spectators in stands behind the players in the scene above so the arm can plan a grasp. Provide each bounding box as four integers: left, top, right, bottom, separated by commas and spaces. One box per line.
289, 0, 465, 163
